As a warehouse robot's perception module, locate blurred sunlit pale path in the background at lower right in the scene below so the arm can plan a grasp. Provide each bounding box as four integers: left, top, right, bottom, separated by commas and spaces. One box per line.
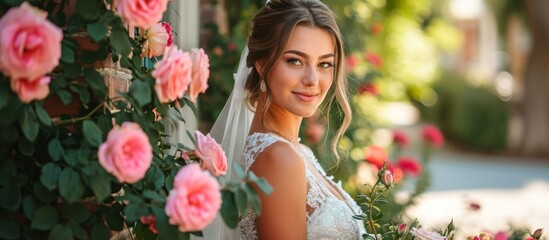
402, 141, 549, 236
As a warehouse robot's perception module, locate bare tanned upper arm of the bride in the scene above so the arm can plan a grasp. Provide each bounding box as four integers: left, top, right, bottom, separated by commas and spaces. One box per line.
251, 142, 307, 240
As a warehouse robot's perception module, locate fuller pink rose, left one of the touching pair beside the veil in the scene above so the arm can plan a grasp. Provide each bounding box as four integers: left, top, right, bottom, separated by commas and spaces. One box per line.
152, 46, 192, 103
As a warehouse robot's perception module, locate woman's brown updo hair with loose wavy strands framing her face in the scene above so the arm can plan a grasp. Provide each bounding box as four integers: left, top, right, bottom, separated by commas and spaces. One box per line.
245, 0, 352, 159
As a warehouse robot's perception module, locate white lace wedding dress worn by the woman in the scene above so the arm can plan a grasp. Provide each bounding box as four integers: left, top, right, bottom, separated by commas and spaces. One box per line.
240, 133, 366, 240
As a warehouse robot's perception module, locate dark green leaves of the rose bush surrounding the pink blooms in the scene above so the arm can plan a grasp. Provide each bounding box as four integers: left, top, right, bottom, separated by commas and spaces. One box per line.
0, 0, 270, 239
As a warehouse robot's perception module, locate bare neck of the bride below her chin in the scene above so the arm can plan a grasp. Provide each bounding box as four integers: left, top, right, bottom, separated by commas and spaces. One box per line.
250, 98, 303, 144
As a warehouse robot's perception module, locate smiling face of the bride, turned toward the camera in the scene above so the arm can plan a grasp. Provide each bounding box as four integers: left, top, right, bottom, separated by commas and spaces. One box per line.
266, 25, 335, 117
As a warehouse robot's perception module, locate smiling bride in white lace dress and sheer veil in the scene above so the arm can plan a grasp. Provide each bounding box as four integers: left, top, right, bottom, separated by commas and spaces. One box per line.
211, 0, 365, 240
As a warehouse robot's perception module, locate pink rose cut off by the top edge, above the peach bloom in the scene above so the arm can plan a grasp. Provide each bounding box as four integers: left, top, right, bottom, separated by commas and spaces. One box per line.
114, 0, 168, 29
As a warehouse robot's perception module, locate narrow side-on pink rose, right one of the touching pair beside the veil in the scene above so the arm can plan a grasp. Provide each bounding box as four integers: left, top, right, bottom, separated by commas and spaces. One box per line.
189, 48, 210, 102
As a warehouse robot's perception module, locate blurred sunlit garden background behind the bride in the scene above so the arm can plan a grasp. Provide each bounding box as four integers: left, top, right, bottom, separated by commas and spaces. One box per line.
171, 0, 549, 236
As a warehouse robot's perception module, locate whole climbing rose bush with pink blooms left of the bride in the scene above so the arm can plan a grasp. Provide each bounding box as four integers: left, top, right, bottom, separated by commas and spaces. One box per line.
0, 0, 269, 239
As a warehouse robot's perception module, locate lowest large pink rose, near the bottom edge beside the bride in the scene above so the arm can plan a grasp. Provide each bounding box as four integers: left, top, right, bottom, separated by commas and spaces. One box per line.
164, 164, 221, 232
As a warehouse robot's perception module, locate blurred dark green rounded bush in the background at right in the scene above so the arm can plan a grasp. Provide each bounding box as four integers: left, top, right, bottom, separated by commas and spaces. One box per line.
416, 72, 509, 151
